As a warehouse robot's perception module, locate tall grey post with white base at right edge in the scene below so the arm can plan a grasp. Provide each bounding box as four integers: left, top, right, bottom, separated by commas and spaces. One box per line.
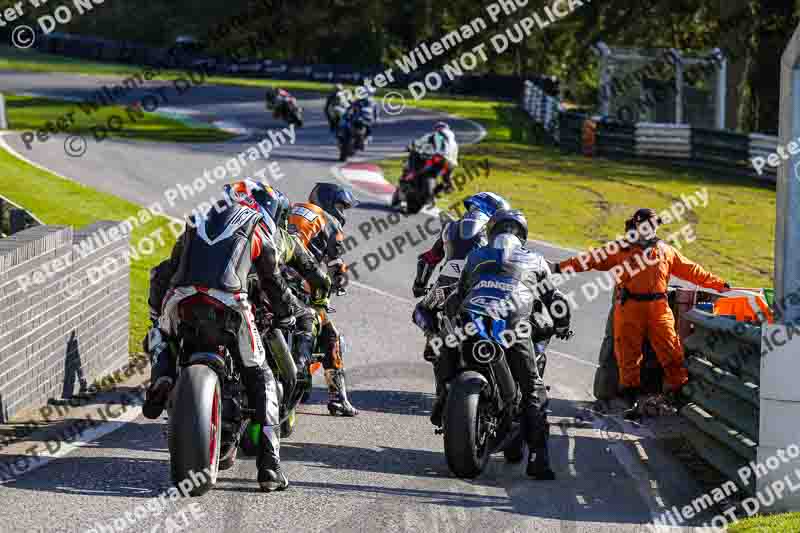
757, 19, 800, 512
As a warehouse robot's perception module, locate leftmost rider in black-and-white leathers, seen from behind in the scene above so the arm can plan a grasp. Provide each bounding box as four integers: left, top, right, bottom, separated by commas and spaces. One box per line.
143, 180, 295, 492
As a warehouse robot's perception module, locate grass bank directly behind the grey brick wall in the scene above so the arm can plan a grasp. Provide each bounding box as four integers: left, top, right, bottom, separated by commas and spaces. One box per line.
0, 143, 175, 353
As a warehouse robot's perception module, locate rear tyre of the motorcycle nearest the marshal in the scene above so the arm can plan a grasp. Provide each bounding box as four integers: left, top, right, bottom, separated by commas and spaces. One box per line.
444, 383, 489, 479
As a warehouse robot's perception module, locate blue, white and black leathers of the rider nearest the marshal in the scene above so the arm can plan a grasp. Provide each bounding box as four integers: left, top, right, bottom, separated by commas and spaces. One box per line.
442, 236, 570, 479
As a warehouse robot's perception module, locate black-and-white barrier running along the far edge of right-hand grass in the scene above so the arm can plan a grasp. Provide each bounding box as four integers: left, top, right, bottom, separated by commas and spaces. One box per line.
522, 82, 778, 183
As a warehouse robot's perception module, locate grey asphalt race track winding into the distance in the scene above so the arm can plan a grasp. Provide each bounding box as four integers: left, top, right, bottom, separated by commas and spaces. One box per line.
0, 73, 708, 533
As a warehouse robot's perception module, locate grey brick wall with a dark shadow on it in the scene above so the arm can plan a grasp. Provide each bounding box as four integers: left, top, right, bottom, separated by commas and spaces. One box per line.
0, 222, 130, 422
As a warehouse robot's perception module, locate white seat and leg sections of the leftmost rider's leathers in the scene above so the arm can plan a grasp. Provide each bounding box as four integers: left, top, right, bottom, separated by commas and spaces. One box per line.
158, 287, 280, 426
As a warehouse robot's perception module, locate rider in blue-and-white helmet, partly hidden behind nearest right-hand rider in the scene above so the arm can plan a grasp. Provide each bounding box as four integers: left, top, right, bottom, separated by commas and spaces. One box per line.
412, 192, 510, 426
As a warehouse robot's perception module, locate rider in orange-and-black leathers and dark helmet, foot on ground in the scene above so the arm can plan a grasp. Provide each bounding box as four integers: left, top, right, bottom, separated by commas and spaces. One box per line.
289, 183, 358, 416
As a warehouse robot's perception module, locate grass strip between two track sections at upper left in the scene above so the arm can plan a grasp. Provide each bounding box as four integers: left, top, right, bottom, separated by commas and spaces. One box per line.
6, 95, 235, 142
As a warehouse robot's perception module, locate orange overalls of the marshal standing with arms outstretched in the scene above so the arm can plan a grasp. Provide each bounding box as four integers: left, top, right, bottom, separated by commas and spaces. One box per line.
559, 239, 725, 390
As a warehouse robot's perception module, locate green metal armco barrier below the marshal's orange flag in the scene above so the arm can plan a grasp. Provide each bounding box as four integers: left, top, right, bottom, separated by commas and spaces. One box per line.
680, 309, 761, 493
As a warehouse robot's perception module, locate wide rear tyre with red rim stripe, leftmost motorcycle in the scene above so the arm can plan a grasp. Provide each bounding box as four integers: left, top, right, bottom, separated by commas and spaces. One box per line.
169, 365, 222, 496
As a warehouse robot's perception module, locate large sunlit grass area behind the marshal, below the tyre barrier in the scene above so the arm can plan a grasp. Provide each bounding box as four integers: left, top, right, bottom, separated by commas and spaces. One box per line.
381, 98, 775, 287
